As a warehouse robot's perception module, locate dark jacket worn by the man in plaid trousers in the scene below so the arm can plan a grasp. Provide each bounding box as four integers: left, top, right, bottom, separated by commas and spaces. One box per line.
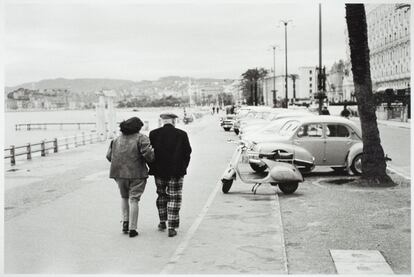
149, 124, 191, 178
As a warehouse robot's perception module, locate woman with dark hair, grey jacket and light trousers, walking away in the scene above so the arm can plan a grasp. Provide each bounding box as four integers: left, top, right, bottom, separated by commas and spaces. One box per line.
106, 117, 154, 238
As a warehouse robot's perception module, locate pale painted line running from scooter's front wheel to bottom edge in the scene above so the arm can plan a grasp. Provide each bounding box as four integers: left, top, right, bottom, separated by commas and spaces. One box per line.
160, 178, 221, 274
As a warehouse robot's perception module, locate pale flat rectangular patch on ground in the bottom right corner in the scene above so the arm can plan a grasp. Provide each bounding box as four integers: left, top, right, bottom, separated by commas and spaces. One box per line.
329, 249, 394, 275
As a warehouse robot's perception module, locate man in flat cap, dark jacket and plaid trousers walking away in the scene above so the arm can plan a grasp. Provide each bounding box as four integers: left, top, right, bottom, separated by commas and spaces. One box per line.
149, 113, 191, 237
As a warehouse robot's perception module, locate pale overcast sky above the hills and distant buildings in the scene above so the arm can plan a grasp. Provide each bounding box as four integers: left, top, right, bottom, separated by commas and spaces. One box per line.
3, 0, 346, 86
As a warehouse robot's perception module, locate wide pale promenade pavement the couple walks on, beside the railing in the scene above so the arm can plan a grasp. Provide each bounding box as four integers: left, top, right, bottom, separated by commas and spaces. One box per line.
4, 116, 286, 274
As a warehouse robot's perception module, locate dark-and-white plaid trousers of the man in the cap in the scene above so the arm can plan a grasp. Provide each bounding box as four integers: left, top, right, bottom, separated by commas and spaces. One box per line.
155, 177, 184, 228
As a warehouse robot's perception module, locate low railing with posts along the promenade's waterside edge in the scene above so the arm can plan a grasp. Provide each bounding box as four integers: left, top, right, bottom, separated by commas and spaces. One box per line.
4, 132, 104, 166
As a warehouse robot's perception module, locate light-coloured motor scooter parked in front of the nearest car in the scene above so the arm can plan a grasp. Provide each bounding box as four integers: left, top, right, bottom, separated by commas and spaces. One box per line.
221, 140, 304, 194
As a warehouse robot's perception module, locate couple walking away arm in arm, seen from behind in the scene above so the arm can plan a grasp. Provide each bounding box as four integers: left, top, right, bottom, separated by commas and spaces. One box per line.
106, 113, 191, 237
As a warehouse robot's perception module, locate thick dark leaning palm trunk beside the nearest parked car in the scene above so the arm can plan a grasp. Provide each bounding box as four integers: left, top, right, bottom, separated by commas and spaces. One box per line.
346, 4, 391, 183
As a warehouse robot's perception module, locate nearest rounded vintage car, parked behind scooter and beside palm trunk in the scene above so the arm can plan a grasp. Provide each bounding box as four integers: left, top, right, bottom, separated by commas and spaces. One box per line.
249, 115, 362, 175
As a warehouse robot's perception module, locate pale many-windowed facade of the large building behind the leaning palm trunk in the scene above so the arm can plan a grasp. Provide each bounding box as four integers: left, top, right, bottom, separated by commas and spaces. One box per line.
343, 4, 411, 100
